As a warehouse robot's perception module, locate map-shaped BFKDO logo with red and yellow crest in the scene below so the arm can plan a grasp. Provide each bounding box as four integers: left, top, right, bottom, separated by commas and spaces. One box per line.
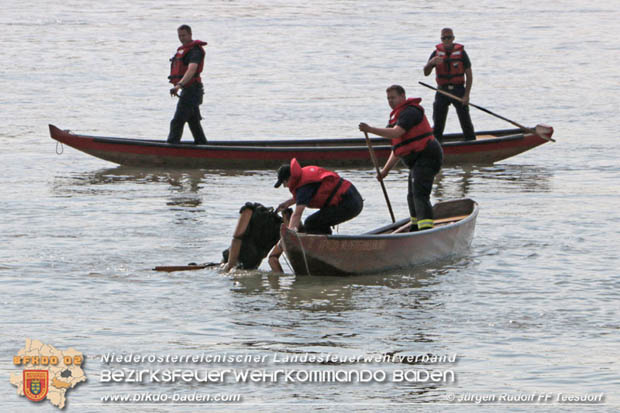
11, 339, 86, 409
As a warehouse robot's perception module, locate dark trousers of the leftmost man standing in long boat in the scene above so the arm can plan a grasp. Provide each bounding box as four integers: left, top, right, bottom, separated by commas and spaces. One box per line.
168, 83, 207, 144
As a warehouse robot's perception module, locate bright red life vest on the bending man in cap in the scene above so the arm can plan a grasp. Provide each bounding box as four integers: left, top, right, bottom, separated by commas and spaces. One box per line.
288, 158, 351, 209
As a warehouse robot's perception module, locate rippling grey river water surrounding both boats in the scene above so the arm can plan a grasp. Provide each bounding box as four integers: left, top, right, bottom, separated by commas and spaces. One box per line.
0, 0, 620, 412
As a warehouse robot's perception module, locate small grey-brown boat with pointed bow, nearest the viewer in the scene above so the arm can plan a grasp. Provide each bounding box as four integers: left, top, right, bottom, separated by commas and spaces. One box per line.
280, 198, 478, 275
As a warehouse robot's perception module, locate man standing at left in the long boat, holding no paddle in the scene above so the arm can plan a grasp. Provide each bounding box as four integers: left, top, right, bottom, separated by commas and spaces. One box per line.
168, 24, 207, 144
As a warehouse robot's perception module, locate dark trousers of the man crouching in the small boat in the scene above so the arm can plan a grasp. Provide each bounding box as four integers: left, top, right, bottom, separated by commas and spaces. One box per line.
304, 184, 364, 234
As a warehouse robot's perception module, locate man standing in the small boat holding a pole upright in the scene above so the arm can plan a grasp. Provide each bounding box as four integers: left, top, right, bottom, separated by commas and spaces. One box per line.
359, 85, 443, 231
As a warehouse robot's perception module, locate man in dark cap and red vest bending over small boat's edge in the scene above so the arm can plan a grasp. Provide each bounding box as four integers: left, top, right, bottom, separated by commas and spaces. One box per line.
269, 158, 364, 272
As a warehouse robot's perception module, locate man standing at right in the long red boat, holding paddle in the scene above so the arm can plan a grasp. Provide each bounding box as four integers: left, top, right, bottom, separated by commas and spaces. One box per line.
424, 27, 476, 142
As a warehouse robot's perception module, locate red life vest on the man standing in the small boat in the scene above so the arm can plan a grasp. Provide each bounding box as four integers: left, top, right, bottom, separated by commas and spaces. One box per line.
388, 98, 435, 157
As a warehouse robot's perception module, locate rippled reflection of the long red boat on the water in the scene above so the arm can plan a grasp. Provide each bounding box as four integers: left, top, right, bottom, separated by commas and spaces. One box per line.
51, 164, 553, 217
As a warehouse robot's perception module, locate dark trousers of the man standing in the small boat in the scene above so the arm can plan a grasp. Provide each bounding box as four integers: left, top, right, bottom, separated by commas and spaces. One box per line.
403, 139, 443, 221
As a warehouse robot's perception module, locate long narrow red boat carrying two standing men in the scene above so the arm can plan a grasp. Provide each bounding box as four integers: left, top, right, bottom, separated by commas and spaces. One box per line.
49, 125, 553, 169
